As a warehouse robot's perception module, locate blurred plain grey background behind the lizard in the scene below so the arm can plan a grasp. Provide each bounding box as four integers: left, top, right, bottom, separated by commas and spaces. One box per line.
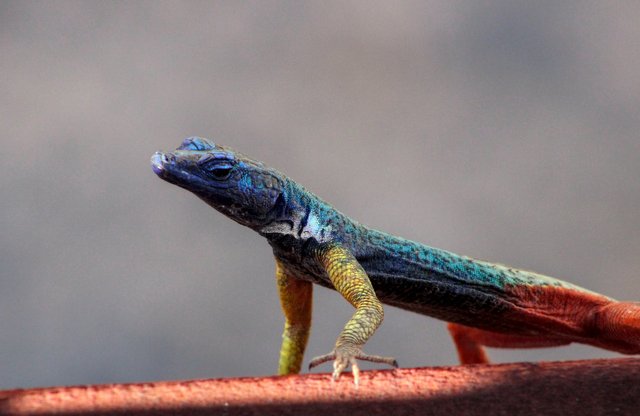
0, 0, 640, 388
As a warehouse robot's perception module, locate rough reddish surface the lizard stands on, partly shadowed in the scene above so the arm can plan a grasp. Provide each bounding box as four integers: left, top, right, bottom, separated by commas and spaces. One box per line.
0, 358, 640, 416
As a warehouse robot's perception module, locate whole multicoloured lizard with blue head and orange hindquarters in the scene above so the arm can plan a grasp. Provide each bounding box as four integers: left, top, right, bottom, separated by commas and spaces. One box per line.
151, 137, 640, 385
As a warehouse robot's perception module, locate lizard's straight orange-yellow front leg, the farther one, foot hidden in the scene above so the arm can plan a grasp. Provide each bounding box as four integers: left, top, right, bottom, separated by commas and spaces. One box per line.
276, 259, 313, 375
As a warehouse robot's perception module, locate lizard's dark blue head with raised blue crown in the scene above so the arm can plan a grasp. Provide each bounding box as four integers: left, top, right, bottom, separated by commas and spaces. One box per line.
151, 137, 285, 229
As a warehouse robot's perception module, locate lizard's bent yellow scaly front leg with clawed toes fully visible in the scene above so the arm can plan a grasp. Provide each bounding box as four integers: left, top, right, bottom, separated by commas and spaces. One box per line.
309, 244, 398, 385
